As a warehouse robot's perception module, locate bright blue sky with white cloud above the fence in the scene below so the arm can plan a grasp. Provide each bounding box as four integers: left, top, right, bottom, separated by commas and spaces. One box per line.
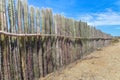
28, 0, 120, 36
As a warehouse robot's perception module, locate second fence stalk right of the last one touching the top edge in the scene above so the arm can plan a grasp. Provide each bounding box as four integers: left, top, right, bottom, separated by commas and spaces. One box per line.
36, 8, 43, 77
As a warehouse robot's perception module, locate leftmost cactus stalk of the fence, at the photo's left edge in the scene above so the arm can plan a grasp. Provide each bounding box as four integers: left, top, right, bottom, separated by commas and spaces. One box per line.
0, 0, 8, 80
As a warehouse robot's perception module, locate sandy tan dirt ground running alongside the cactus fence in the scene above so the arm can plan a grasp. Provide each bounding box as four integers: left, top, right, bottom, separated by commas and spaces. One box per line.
42, 42, 120, 80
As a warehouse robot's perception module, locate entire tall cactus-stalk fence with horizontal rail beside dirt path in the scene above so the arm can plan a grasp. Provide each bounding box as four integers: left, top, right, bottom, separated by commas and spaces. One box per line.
0, 0, 112, 80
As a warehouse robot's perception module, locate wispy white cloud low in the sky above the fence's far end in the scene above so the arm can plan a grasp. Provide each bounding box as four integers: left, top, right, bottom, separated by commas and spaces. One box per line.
79, 9, 120, 26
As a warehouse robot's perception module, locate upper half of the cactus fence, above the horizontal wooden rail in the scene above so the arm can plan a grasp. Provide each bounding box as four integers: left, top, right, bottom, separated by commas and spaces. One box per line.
0, 0, 110, 38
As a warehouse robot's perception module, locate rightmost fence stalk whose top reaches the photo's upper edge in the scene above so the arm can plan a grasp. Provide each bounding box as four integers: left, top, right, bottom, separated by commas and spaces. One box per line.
21, 0, 28, 80
